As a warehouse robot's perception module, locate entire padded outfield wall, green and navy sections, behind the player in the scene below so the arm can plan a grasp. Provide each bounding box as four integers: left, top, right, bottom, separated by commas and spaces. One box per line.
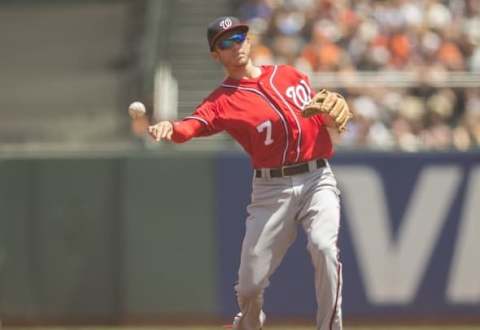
0, 152, 480, 324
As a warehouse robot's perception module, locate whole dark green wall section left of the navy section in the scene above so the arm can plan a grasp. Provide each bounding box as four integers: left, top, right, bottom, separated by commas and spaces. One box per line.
0, 155, 216, 322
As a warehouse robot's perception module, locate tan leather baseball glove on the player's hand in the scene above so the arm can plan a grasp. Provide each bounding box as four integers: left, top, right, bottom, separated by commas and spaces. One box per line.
302, 89, 353, 133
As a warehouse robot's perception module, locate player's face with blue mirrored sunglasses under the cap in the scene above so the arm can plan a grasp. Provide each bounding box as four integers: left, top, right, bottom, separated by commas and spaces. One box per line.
212, 31, 250, 69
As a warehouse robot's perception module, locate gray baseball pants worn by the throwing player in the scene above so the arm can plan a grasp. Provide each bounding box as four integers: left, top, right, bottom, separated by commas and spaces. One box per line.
235, 165, 342, 330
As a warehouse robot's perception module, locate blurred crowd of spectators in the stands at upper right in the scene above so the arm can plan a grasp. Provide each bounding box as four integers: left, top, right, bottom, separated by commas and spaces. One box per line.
236, 0, 480, 151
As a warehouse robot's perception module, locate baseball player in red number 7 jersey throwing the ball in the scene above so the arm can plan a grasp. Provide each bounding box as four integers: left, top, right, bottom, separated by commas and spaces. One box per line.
148, 16, 351, 330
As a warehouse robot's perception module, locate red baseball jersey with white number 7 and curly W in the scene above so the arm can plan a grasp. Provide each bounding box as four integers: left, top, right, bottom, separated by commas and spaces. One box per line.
172, 65, 333, 168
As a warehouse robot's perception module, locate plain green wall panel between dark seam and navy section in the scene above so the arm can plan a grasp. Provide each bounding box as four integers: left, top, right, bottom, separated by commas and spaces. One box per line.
123, 157, 216, 316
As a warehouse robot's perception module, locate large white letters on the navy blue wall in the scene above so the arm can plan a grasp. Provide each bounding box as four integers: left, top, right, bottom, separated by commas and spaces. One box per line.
335, 166, 480, 305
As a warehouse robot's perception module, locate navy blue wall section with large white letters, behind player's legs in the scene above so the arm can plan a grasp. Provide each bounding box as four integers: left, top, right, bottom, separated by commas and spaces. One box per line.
216, 153, 480, 321
